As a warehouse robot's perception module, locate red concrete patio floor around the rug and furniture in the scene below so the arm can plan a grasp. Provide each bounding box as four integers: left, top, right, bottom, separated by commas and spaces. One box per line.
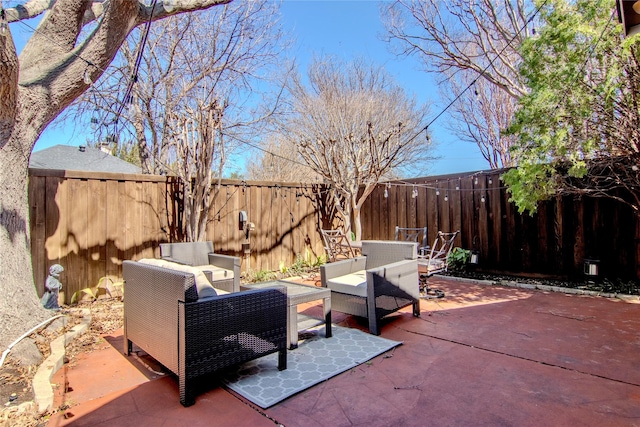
49, 278, 640, 427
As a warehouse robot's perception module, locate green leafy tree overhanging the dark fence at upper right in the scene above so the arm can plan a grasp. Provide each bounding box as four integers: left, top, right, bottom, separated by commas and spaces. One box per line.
503, 0, 640, 212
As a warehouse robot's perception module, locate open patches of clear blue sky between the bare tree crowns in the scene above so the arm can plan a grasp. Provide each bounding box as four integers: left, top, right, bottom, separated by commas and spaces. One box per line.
23, 0, 489, 175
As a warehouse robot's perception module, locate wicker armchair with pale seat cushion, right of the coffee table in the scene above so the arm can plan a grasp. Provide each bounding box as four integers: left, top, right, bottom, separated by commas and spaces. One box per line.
320, 241, 420, 335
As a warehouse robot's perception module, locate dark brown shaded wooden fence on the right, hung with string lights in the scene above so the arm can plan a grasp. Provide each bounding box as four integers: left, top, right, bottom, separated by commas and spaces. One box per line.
362, 170, 640, 279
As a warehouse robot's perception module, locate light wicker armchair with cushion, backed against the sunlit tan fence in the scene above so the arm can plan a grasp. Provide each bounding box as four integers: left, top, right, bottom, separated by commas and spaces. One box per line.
160, 242, 241, 292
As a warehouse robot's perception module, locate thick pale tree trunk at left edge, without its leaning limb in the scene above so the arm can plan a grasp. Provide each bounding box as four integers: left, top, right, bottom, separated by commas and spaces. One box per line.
0, 21, 46, 350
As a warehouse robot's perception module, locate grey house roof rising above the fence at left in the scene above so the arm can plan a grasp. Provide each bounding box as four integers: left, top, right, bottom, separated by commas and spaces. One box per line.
29, 145, 142, 173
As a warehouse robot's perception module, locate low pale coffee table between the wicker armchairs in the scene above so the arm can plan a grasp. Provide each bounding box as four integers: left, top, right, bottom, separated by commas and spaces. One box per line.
240, 280, 331, 349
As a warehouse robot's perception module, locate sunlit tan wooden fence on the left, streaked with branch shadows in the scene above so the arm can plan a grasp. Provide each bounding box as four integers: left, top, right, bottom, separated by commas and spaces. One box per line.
29, 169, 326, 303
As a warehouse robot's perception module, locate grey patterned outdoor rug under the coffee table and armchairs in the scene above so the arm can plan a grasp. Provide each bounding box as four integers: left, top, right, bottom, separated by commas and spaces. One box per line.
223, 325, 402, 409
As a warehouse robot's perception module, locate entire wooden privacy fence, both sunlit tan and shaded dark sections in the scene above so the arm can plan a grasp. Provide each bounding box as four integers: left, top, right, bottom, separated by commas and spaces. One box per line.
29, 169, 640, 302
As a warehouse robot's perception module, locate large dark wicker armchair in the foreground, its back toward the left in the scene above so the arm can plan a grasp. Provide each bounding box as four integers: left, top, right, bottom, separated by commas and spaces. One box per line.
123, 261, 287, 406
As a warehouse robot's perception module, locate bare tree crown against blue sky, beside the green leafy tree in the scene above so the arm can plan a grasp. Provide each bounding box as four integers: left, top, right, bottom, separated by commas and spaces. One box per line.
383, 0, 534, 168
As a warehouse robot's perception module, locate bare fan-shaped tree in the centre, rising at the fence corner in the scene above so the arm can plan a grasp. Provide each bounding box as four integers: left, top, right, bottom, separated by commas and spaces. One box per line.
278, 58, 431, 238
